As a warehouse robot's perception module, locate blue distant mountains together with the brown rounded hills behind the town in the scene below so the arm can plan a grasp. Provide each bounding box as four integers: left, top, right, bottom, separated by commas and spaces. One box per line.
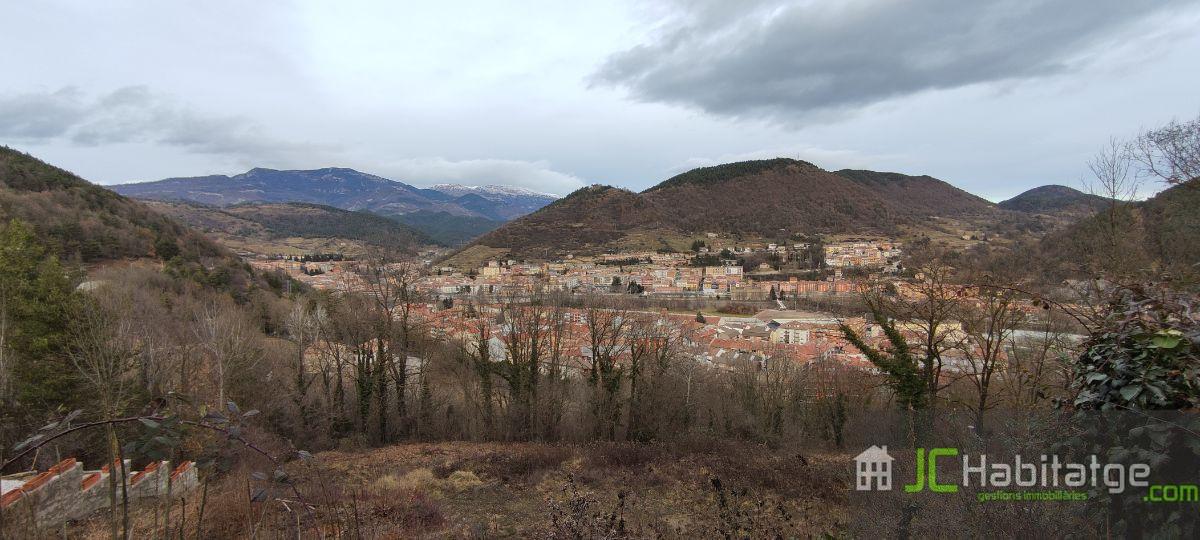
100, 158, 1142, 264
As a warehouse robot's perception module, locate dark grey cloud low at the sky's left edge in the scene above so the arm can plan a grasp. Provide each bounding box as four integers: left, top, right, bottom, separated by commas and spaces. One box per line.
0, 86, 324, 161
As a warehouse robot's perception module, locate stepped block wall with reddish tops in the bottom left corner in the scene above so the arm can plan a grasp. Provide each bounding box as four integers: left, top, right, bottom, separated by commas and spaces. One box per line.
0, 458, 199, 527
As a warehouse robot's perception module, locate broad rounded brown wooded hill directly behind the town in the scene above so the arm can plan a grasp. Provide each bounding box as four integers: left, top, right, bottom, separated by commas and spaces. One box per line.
465, 158, 1025, 258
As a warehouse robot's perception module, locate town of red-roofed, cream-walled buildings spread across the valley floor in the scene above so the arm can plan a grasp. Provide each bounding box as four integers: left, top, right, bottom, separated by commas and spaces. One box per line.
243, 241, 1080, 391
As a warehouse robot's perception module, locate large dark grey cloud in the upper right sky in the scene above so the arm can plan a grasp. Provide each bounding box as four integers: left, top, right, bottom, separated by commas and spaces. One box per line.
593, 0, 1194, 122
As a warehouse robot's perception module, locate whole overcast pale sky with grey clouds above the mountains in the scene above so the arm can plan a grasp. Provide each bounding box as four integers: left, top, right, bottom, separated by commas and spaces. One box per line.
0, 0, 1200, 200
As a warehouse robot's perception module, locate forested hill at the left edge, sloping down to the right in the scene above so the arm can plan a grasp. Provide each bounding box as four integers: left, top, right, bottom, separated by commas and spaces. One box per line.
0, 146, 223, 263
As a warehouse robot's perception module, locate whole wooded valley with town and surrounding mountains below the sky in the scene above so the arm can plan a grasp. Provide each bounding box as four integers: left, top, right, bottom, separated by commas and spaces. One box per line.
0, 123, 1200, 538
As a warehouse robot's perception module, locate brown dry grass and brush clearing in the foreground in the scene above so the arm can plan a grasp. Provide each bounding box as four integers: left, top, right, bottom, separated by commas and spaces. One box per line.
65, 439, 850, 538
